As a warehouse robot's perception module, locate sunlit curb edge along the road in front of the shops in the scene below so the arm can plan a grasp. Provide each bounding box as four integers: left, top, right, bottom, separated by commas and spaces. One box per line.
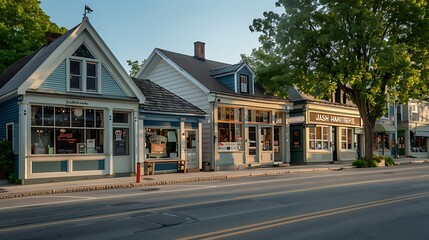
0, 167, 344, 200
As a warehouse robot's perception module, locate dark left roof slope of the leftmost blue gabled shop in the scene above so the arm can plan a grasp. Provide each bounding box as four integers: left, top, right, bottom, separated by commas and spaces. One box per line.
0, 24, 76, 97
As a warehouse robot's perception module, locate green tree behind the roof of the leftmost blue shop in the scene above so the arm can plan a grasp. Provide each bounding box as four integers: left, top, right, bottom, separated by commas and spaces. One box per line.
0, 0, 67, 74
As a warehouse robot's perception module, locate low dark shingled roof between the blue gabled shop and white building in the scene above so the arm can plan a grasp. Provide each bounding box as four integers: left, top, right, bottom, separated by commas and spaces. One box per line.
133, 78, 206, 115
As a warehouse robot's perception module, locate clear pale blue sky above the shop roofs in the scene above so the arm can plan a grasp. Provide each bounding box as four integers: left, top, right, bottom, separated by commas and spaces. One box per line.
40, 0, 279, 70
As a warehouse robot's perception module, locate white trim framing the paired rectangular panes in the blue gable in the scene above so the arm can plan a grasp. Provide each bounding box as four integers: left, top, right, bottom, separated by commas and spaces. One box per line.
66, 56, 101, 94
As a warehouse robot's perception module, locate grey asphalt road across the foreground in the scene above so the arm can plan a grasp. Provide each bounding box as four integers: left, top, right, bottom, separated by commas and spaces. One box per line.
0, 164, 429, 240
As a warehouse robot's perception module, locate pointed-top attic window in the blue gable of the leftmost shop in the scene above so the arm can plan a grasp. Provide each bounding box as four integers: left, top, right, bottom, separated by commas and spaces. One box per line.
68, 44, 100, 92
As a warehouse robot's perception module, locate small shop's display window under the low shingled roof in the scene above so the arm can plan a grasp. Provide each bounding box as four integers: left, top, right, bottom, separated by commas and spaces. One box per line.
145, 128, 179, 158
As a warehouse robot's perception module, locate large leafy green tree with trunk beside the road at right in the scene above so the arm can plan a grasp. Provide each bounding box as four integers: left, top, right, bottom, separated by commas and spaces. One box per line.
245, 0, 429, 160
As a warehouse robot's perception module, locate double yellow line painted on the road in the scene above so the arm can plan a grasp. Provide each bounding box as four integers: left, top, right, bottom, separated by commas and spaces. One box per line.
178, 192, 429, 240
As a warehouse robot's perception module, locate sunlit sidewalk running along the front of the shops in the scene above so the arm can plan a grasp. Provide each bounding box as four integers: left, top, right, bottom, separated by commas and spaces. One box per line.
0, 158, 429, 200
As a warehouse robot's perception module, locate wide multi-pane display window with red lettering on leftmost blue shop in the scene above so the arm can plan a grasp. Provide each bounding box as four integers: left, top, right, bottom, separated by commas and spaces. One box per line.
31, 105, 104, 154
